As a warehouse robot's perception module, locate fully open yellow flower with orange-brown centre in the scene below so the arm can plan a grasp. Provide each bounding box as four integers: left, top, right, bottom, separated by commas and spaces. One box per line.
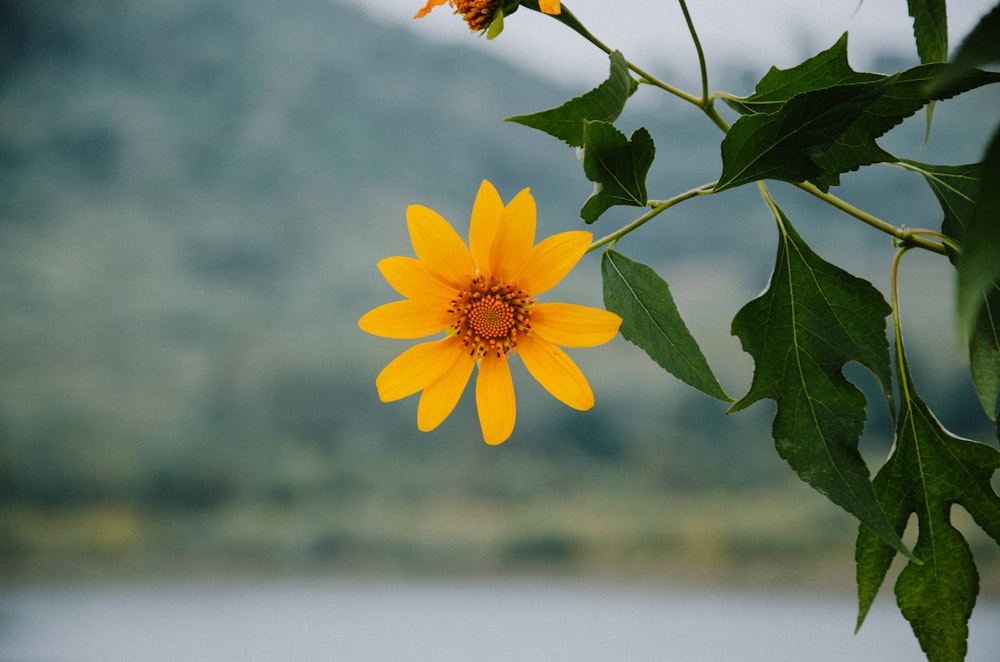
358, 181, 621, 444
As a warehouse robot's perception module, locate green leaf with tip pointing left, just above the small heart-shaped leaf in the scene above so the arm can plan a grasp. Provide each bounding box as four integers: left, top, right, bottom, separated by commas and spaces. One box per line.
505, 51, 637, 147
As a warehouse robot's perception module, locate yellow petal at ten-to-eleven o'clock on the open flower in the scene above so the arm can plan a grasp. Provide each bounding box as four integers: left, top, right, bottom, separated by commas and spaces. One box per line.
406, 205, 476, 290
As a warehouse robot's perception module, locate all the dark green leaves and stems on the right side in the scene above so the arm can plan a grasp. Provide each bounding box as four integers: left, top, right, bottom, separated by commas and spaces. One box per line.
504, 0, 1000, 661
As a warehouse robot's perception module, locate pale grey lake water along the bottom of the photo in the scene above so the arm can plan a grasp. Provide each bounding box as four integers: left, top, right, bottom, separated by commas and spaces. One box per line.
0, 578, 1000, 662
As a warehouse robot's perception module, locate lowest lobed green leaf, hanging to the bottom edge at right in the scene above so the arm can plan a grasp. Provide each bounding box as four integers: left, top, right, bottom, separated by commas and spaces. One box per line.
855, 336, 1000, 662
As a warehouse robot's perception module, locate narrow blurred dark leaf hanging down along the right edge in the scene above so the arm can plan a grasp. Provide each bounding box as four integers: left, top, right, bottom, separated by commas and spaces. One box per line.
958, 130, 1000, 334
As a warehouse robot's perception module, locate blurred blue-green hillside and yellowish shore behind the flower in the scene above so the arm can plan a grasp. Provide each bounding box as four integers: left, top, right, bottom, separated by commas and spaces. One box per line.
0, 0, 1000, 659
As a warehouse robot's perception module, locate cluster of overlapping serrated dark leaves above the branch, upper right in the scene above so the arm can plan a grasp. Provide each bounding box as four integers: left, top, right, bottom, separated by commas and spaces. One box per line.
717, 34, 1000, 191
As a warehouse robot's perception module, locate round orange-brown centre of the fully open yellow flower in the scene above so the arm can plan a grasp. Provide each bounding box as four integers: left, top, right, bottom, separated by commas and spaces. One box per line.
448, 276, 535, 358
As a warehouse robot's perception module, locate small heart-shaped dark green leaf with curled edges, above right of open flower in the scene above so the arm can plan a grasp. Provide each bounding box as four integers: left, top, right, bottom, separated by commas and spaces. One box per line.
580, 122, 656, 223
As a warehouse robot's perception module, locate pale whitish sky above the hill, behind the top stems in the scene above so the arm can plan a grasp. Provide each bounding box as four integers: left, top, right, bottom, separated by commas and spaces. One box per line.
336, 0, 995, 86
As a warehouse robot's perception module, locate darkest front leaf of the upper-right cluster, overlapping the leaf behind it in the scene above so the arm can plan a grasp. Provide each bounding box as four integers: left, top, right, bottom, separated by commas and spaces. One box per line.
715, 78, 894, 191
